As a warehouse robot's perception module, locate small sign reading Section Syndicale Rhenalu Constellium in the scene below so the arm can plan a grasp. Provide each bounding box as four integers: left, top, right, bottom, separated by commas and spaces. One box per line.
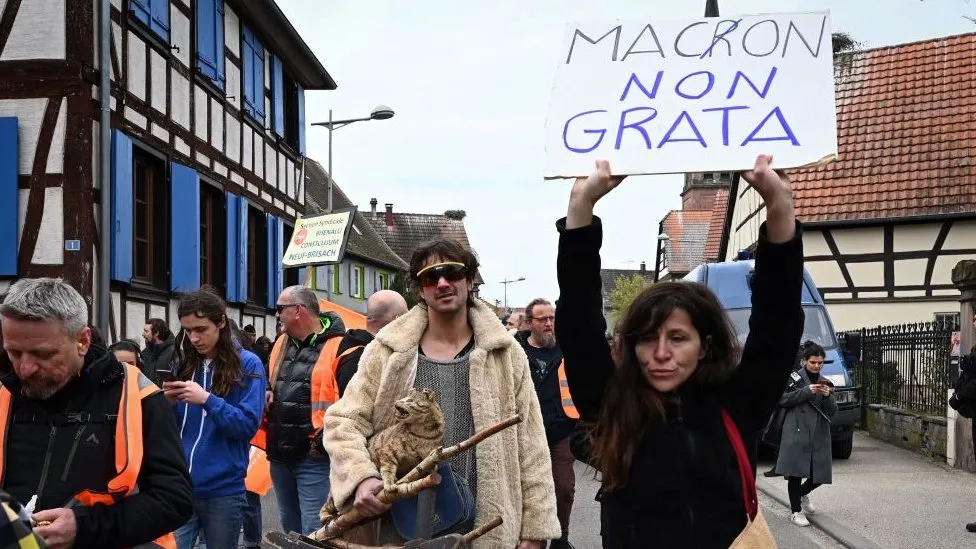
282, 206, 356, 267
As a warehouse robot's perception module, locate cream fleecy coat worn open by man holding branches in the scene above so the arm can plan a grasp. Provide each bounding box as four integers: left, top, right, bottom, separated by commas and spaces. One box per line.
324, 302, 560, 549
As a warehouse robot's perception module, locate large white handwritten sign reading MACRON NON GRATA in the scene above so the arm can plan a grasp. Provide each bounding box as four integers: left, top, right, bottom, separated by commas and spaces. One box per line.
545, 12, 837, 179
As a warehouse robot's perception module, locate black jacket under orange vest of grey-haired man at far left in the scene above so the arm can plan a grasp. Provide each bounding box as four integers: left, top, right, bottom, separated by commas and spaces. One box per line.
0, 347, 193, 549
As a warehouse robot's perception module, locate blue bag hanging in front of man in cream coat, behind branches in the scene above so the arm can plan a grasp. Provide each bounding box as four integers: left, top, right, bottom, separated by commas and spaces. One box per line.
390, 463, 475, 540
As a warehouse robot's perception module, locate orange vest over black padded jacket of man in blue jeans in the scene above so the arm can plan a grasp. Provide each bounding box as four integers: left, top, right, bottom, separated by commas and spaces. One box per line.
251, 334, 363, 450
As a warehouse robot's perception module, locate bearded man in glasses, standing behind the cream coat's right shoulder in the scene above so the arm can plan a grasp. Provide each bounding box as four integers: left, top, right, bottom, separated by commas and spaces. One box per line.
515, 298, 579, 549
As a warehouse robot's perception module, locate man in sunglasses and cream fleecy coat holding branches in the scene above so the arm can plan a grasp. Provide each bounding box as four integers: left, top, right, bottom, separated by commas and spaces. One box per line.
325, 240, 560, 549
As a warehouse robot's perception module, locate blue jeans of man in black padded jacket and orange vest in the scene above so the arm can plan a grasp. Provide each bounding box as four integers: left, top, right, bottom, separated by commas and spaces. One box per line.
271, 457, 329, 535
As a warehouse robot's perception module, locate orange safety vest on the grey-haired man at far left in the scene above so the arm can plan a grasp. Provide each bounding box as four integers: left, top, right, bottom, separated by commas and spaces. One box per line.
0, 364, 176, 549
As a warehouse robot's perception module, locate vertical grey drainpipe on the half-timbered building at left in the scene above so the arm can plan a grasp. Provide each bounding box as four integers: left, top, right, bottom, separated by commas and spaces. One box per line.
95, 0, 112, 339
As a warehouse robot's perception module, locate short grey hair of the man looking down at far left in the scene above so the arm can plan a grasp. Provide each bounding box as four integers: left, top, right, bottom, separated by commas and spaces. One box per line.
0, 278, 88, 335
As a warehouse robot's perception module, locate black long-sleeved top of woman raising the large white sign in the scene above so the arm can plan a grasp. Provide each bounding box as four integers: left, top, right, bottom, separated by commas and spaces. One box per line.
556, 217, 803, 549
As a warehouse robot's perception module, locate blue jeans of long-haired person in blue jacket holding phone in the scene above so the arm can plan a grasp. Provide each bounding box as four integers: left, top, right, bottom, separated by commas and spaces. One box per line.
175, 494, 247, 549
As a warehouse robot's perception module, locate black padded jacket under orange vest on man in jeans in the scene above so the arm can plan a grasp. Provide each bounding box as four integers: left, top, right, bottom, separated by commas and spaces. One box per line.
267, 312, 346, 462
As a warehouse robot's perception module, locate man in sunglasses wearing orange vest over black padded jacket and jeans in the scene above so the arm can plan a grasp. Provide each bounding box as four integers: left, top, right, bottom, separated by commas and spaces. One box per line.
259, 286, 346, 534
